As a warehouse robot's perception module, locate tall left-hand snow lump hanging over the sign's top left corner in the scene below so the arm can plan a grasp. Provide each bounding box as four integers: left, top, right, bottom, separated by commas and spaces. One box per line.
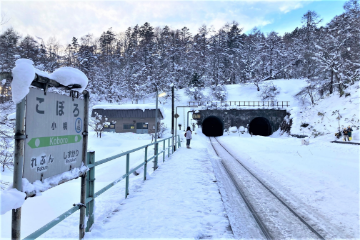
11, 58, 35, 104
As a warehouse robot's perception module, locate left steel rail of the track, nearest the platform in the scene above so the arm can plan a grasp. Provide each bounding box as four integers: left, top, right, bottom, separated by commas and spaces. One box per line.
209, 137, 274, 239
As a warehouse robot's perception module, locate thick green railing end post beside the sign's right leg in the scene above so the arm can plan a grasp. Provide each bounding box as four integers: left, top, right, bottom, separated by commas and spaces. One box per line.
85, 151, 95, 232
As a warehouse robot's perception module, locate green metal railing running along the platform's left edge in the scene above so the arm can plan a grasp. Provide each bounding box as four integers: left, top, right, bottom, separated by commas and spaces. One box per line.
24, 135, 181, 239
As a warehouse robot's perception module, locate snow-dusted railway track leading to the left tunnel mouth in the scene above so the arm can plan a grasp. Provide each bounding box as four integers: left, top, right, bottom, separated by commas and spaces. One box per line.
209, 137, 325, 239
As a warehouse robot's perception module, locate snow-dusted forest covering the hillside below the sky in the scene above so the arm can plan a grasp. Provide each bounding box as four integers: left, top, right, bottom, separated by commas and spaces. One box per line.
0, 0, 360, 102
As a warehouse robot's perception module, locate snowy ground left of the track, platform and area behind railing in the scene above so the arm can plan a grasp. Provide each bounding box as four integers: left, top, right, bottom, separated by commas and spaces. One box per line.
1, 129, 232, 238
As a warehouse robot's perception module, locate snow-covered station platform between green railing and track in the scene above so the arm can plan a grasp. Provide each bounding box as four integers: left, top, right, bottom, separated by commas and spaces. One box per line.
85, 135, 233, 239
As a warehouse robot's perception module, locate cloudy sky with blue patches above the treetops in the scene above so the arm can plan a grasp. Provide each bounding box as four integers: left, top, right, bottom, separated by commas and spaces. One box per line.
0, 0, 345, 45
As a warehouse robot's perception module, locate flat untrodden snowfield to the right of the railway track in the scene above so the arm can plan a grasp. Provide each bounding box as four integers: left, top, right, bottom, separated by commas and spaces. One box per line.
214, 134, 360, 238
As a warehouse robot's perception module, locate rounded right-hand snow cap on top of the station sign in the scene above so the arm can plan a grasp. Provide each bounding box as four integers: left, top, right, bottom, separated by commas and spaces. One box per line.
50, 67, 89, 92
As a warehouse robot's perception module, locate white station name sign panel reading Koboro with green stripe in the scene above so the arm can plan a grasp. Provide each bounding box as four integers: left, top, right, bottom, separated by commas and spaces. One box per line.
23, 88, 84, 183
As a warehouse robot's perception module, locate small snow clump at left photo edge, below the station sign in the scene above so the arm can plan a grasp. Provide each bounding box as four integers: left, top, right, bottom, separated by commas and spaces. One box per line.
0, 188, 26, 215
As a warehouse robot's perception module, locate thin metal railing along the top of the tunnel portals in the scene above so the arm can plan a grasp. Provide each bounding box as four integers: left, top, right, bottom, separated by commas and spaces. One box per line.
188, 101, 290, 108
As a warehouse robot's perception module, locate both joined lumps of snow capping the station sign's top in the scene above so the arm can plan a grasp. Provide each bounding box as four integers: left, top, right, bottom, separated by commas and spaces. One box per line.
11, 58, 89, 104
